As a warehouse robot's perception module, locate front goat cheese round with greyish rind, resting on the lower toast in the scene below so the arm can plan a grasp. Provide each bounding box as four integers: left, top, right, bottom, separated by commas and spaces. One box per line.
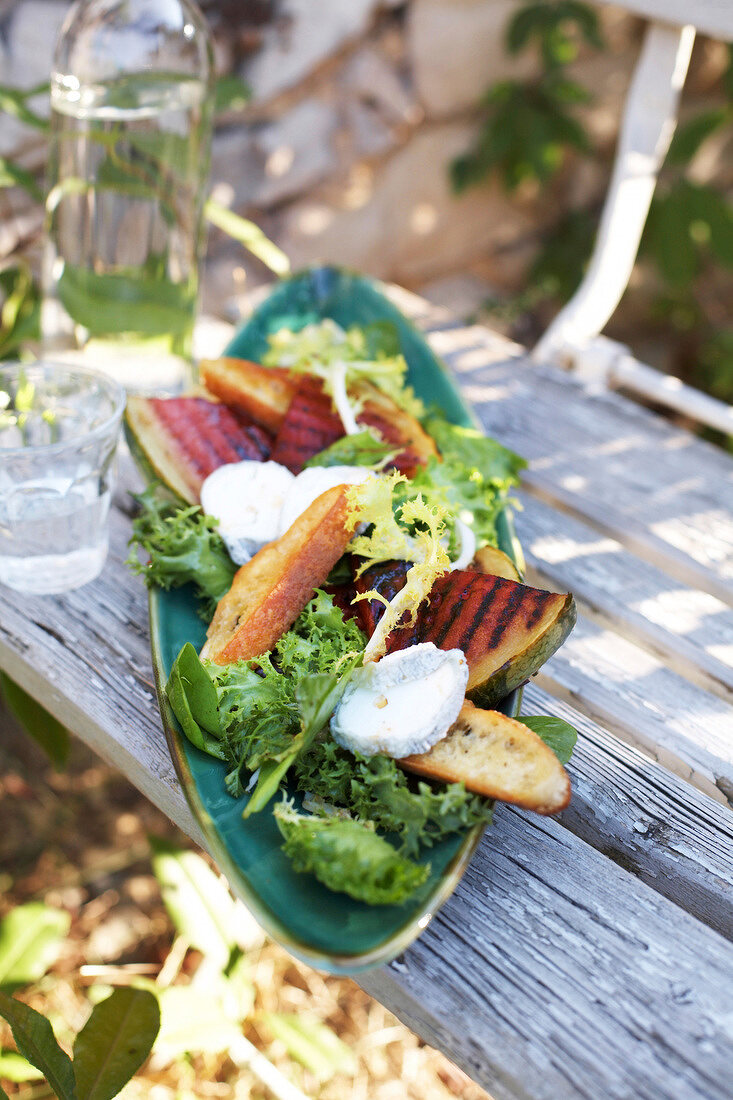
330, 641, 468, 758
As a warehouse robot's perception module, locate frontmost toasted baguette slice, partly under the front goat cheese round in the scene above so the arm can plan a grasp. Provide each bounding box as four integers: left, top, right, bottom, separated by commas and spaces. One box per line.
400, 701, 570, 814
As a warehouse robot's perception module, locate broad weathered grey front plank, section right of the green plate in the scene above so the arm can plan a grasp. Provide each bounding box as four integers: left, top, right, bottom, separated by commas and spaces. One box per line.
358, 809, 733, 1100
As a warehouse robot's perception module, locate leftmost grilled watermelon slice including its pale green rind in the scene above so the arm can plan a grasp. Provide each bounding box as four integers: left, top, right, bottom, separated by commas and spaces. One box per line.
125, 397, 272, 504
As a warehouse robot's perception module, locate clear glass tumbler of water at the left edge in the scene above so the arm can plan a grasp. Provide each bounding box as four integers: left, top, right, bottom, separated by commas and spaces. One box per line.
0, 362, 124, 594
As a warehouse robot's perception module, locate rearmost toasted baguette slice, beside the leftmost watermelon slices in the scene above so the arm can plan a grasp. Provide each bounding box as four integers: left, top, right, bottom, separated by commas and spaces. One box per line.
198, 359, 299, 431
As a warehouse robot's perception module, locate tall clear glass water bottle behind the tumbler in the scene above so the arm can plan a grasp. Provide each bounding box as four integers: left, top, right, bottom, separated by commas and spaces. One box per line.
42, 0, 212, 393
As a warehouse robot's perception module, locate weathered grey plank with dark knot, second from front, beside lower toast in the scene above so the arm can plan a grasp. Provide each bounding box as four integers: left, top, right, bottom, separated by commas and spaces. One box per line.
523, 683, 733, 939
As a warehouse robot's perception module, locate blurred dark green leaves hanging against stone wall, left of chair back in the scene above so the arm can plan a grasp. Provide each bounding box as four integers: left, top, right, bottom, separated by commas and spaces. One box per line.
451, 0, 603, 191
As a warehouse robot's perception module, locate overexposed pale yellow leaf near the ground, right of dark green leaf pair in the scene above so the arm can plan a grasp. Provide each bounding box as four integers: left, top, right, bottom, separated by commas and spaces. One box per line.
154, 986, 242, 1062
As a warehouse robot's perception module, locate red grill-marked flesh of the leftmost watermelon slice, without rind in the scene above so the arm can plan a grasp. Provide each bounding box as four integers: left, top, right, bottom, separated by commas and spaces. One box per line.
151, 397, 272, 480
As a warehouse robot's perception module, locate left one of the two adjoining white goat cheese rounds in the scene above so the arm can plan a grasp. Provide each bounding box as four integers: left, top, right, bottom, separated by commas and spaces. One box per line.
201, 460, 295, 565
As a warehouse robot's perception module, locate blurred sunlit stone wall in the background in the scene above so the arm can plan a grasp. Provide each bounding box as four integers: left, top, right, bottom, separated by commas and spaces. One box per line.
0, 0, 721, 327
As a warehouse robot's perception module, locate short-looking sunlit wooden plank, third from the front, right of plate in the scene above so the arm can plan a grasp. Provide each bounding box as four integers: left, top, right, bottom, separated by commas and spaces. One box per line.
536, 615, 733, 803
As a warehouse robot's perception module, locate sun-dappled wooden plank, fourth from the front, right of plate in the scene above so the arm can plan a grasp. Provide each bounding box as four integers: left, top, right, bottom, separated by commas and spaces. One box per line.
515, 493, 733, 703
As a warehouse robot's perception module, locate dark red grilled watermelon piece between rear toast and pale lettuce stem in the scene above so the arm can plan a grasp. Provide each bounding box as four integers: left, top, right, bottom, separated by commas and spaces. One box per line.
271, 377, 344, 474
